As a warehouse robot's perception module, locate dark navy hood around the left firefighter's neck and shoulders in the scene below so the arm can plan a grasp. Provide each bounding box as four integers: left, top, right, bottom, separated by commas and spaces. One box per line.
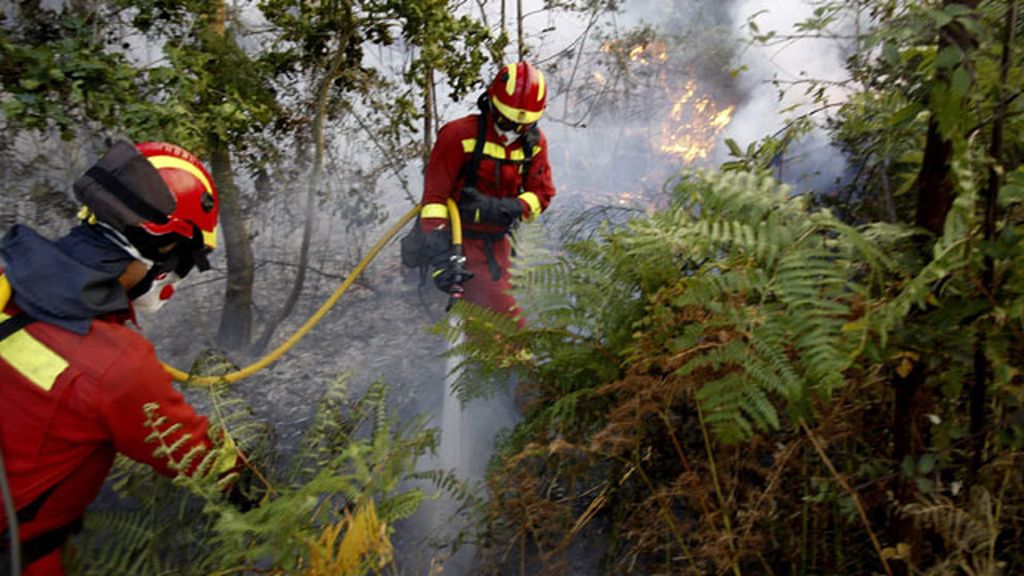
0, 224, 134, 334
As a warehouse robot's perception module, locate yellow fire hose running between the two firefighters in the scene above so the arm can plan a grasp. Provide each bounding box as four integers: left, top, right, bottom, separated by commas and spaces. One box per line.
0, 199, 462, 385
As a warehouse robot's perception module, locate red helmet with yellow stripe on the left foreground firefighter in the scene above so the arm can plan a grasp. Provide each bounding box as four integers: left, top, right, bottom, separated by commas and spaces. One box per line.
135, 142, 219, 250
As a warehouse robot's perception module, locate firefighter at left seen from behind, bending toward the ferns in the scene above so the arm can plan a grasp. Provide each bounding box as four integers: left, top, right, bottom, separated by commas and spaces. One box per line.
0, 141, 234, 576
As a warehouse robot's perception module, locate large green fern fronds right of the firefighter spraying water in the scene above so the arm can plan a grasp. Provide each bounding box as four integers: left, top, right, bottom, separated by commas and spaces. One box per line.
475, 168, 892, 441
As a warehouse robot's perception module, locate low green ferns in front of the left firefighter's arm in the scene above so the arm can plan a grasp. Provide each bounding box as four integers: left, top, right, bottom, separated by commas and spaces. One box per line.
71, 376, 436, 575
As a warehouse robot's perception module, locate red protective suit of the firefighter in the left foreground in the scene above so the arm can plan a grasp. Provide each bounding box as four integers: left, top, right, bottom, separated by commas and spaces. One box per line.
0, 304, 210, 576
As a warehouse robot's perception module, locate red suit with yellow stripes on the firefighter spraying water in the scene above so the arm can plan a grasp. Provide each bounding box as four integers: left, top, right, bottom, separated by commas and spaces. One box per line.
420, 114, 555, 315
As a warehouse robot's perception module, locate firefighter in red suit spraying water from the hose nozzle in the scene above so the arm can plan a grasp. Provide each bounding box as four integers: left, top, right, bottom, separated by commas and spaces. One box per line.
420, 61, 555, 316
